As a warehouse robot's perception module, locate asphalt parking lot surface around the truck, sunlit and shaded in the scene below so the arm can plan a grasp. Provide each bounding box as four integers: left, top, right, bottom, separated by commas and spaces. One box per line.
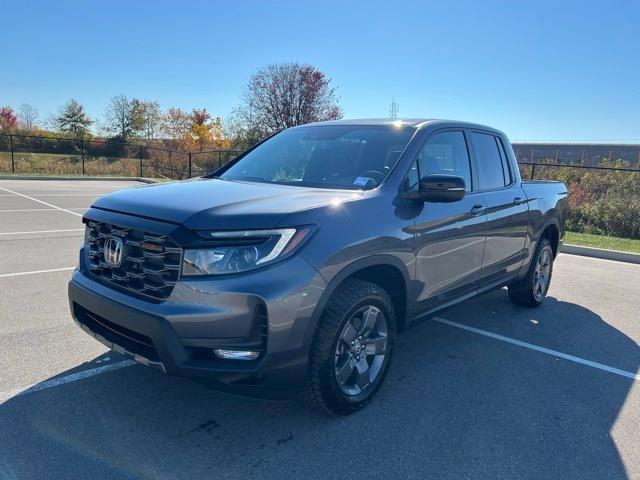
0, 180, 640, 479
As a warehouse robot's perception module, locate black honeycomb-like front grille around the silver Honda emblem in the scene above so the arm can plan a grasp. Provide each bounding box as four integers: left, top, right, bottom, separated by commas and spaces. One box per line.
87, 220, 182, 300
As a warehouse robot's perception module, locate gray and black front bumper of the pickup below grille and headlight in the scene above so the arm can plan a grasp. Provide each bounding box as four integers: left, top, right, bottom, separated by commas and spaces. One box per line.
68, 255, 326, 394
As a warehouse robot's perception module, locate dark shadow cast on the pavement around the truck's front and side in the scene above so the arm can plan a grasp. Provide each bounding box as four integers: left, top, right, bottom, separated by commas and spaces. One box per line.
0, 292, 640, 479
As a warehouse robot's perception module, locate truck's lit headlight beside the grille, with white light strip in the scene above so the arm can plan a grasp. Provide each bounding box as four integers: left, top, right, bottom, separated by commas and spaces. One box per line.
182, 226, 314, 276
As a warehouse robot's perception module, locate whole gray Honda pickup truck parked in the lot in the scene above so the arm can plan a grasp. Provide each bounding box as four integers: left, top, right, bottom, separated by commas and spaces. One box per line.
69, 119, 567, 414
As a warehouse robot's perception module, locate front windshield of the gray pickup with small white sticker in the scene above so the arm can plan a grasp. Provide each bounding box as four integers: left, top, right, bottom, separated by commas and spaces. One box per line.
221, 125, 415, 189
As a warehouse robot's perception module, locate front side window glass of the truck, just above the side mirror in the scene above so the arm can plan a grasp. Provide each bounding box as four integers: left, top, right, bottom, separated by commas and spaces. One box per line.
418, 132, 471, 192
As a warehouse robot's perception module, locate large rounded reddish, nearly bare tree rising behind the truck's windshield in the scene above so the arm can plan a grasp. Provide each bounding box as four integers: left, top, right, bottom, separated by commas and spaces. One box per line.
237, 63, 342, 142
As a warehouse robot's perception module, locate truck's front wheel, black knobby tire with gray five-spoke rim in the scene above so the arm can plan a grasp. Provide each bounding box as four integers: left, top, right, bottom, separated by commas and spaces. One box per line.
303, 279, 396, 415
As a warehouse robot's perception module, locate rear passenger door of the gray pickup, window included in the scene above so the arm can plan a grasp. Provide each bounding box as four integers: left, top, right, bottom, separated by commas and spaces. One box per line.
468, 130, 529, 285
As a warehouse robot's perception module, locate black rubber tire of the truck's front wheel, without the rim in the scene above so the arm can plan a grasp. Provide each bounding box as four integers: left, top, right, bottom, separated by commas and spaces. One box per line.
302, 279, 396, 415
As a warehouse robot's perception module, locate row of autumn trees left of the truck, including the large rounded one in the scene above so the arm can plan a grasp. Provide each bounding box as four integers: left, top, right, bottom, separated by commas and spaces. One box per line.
0, 62, 342, 152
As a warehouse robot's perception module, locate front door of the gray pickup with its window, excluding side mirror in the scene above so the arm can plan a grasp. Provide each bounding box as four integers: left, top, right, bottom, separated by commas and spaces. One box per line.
410, 130, 486, 309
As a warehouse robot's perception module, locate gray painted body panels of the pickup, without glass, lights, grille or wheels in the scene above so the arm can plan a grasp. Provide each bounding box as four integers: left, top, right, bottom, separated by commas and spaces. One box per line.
69, 119, 567, 391
